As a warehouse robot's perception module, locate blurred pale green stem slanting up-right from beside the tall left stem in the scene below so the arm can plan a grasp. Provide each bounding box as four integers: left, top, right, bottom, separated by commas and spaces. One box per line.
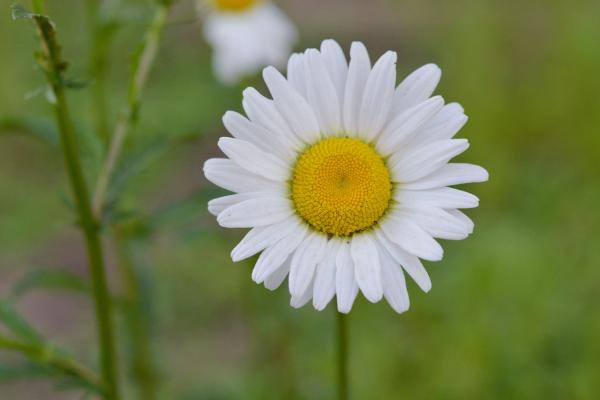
93, 1, 171, 217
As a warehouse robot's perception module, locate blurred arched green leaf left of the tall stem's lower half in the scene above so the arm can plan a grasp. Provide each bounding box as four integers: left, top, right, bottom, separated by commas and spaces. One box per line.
12, 269, 88, 297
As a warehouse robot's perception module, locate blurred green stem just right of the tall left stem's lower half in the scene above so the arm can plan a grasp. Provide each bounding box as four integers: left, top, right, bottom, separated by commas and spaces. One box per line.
113, 229, 159, 400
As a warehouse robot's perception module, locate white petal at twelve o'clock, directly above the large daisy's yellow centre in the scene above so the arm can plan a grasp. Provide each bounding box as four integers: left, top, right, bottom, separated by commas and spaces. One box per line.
342, 42, 371, 137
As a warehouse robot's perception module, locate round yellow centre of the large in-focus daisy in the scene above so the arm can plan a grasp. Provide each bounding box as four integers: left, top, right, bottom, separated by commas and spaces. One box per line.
292, 138, 392, 236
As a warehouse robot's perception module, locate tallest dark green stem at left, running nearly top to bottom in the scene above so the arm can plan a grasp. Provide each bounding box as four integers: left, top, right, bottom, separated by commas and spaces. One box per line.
29, 10, 119, 400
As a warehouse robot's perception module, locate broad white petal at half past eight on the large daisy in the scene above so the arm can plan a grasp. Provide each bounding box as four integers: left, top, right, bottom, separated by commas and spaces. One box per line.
217, 196, 294, 228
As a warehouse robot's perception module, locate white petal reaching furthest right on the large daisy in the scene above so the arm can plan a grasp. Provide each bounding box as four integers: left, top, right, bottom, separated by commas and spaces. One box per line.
402, 163, 489, 190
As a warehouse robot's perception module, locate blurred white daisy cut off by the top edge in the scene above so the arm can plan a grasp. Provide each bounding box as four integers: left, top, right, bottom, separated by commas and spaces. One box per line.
198, 0, 297, 84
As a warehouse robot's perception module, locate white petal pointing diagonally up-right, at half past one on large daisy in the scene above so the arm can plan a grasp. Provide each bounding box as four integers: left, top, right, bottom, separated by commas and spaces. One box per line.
375, 96, 444, 157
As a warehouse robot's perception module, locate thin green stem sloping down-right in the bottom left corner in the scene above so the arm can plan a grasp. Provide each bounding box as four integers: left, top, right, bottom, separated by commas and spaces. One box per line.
0, 335, 102, 391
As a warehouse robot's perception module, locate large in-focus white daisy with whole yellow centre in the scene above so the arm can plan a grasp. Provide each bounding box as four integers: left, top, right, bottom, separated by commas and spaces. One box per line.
204, 40, 488, 313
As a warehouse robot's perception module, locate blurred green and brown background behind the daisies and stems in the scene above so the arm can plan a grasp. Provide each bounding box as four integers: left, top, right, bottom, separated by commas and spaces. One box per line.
0, 0, 600, 400
